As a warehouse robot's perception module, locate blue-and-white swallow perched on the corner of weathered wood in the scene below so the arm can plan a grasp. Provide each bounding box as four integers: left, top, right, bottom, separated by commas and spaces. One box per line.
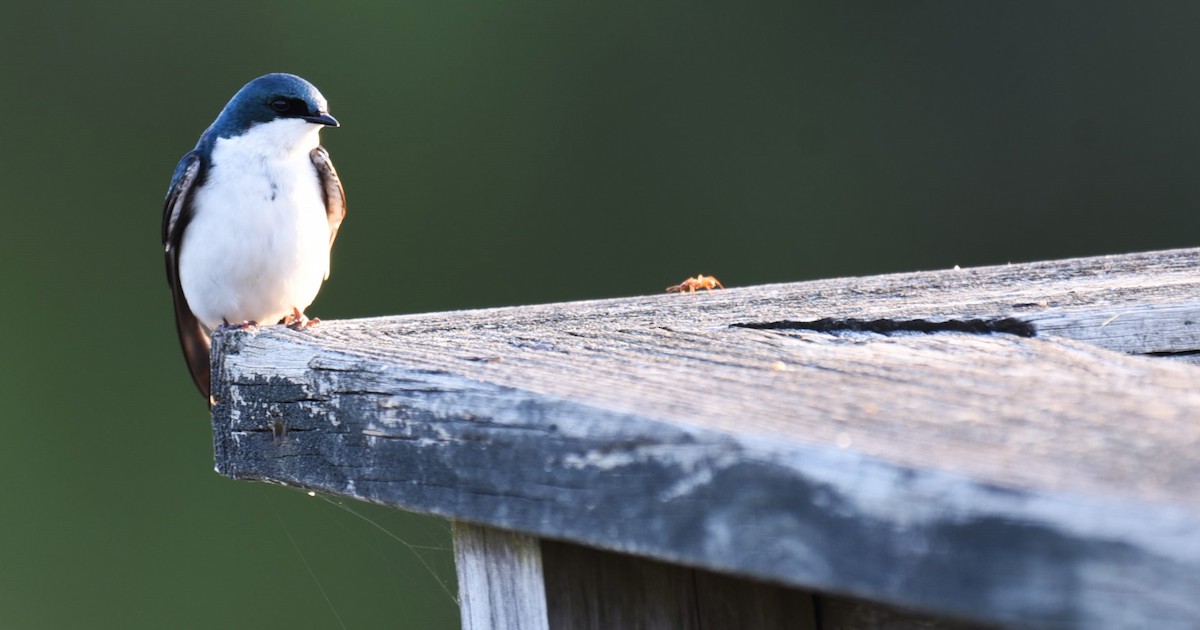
162, 72, 346, 408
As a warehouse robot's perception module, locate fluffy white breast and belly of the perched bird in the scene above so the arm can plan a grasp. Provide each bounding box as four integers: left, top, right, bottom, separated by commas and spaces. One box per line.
179, 120, 329, 329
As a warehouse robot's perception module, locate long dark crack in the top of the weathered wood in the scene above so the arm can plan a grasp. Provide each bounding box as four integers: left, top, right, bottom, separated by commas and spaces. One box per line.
730, 317, 1038, 337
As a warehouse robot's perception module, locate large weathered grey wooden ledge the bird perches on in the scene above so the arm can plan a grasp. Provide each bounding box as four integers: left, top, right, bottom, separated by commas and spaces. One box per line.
214, 251, 1200, 628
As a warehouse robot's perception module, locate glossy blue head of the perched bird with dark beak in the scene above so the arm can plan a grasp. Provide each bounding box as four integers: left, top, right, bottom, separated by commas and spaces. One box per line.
209, 72, 337, 138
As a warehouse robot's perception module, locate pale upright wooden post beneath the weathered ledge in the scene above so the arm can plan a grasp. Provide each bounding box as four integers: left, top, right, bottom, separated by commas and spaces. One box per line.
454, 522, 550, 630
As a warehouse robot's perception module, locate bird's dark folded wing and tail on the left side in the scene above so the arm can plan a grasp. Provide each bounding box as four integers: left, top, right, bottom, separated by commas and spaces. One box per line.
162, 151, 212, 404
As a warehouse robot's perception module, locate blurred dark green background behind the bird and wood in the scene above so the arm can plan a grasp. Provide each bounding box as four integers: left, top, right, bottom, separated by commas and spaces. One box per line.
0, 0, 1200, 628
